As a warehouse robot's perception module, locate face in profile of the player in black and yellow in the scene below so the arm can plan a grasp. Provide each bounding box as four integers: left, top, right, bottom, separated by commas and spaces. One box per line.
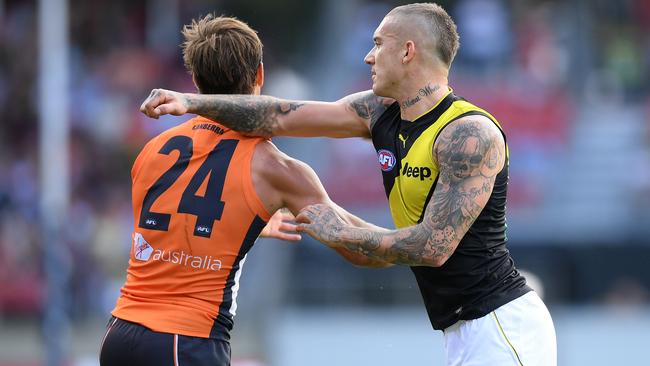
364, 18, 402, 97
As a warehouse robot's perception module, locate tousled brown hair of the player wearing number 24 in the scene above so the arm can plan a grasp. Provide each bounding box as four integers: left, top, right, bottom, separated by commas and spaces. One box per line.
182, 14, 262, 94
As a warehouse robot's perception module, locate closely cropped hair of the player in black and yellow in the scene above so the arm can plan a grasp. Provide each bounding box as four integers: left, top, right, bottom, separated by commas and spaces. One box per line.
389, 3, 460, 66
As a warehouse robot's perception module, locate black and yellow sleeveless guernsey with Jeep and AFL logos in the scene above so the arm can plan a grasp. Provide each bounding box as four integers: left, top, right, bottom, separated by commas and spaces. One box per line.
371, 91, 531, 330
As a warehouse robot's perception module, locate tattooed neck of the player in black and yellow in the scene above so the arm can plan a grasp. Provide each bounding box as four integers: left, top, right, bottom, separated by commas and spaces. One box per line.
398, 78, 449, 121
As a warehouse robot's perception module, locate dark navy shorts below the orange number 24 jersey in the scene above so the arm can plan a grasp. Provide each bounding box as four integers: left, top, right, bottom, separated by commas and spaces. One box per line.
99, 317, 230, 366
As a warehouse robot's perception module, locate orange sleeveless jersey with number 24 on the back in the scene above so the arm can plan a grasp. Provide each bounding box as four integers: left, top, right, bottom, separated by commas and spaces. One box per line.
112, 117, 270, 340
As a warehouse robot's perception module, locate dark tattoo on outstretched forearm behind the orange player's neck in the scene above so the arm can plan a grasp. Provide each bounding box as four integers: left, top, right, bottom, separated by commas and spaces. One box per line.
187, 95, 304, 137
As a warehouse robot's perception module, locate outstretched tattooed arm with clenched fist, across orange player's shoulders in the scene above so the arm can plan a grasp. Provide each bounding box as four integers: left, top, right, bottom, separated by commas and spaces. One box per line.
140, 89, 393, 137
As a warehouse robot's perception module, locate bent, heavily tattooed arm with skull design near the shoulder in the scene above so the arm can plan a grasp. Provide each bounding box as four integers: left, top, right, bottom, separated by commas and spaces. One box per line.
297, 116, 505, 267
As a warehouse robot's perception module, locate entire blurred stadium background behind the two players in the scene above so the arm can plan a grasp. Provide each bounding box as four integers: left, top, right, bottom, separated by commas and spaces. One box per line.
0, 0, 650, 366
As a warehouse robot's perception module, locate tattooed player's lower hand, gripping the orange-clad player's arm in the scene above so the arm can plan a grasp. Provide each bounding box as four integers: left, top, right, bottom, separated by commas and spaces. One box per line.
296, 203, 346, 248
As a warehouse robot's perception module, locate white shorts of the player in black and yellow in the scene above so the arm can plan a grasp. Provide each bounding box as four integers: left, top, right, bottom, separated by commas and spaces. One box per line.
444, 291, 557, 366
